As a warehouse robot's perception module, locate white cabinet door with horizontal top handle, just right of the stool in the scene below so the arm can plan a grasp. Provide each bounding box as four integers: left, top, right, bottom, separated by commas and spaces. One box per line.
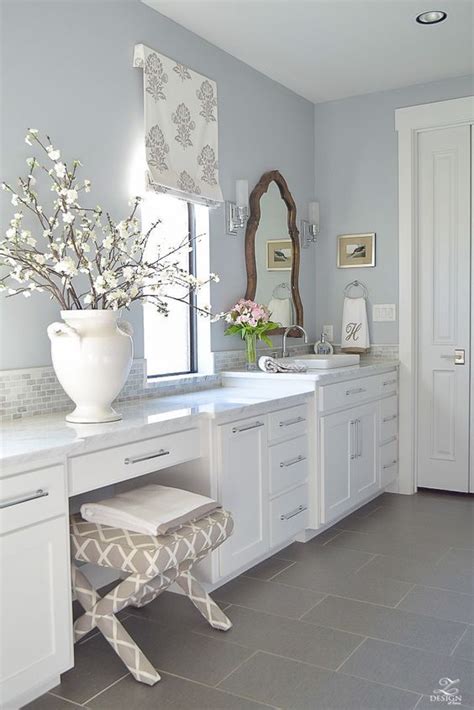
218, 417, 270, 576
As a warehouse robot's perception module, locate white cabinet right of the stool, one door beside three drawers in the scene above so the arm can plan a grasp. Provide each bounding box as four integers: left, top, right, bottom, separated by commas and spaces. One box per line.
213, 403, 311, 582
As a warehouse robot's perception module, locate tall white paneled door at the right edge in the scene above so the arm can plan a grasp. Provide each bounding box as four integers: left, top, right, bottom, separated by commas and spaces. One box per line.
418, 125, 471, 491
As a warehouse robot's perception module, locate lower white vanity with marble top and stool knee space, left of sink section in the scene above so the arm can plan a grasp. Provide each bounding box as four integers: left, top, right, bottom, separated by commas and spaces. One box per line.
0, 388, 311, 708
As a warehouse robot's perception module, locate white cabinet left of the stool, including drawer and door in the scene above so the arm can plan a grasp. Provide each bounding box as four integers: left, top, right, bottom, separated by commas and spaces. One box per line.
0, 466, 73, 708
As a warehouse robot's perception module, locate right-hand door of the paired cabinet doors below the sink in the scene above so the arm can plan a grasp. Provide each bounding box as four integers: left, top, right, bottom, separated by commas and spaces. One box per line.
351, 403, 380, 504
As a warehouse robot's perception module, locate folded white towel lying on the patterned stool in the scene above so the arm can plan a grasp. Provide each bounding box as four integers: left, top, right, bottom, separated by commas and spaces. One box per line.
81, 483, 221, 535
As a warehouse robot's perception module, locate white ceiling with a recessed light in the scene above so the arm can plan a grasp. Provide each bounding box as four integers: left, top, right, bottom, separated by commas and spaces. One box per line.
143, 0, 474, 103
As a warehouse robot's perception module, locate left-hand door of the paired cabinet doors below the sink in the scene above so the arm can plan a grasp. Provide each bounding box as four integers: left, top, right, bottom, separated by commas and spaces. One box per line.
321, 412, 353, 523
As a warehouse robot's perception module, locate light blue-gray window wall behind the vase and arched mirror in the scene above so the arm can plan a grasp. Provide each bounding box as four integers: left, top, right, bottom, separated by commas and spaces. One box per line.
0, 0, 315, 369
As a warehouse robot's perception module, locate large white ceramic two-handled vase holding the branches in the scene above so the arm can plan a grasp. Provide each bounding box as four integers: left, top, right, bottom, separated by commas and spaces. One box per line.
48, 310, 133, 424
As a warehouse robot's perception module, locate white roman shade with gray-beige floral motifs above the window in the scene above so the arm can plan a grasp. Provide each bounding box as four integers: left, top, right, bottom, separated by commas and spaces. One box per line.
133, 44, 223, 207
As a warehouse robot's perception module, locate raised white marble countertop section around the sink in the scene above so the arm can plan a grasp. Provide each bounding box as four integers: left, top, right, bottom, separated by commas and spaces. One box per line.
222, 358, 399, 387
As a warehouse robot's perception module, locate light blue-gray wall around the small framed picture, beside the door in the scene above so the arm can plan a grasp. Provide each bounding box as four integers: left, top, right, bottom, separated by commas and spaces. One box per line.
315, 76, 474, 343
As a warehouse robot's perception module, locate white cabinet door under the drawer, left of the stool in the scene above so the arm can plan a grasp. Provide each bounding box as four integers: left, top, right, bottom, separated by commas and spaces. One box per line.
0, 516, 73, 707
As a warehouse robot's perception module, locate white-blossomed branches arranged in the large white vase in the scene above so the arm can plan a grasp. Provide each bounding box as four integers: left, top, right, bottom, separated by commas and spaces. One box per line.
0, 128, 219, 315
